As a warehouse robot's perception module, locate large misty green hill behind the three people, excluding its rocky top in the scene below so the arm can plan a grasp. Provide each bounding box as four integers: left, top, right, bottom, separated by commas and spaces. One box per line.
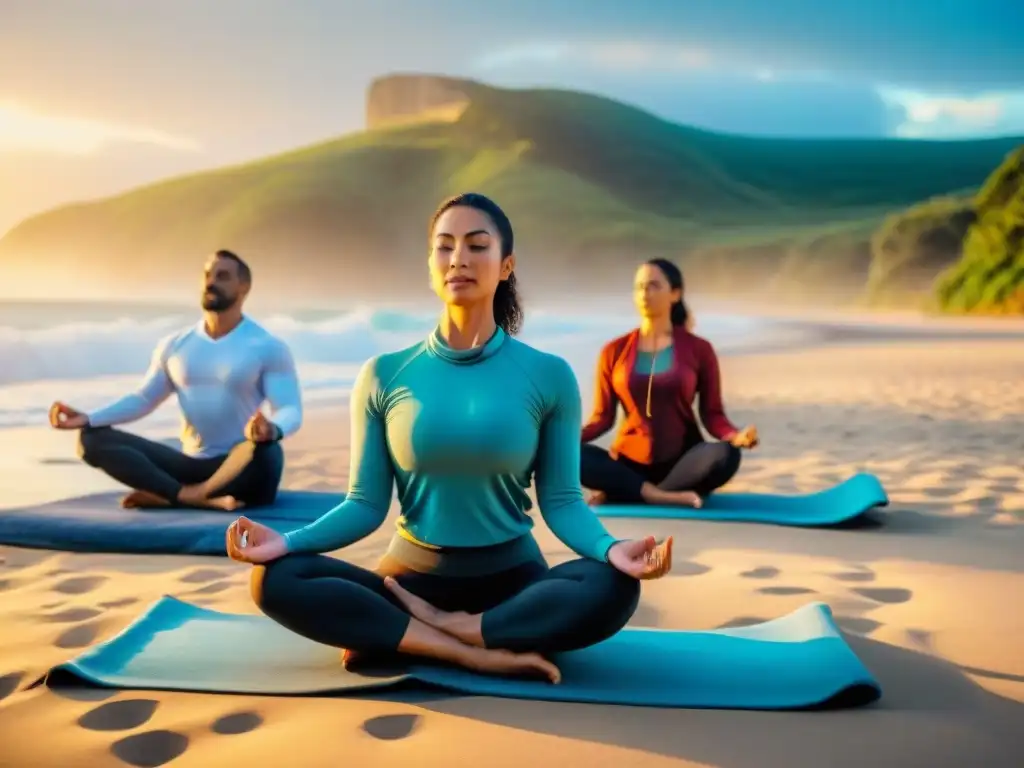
0, 76, 1021, 303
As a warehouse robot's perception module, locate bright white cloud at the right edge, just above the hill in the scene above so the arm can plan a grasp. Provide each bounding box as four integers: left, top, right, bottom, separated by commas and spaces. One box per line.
879, 87, 1024, 138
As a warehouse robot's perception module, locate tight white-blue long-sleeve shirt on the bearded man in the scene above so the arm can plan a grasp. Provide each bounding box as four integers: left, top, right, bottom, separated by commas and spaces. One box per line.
89, 317, 302, 458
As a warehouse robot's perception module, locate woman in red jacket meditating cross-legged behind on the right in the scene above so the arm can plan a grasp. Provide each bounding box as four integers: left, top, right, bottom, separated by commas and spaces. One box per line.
581, 259, 758, 507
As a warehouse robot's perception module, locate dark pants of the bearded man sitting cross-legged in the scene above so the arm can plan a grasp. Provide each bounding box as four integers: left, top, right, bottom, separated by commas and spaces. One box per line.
78, 427, 285, 507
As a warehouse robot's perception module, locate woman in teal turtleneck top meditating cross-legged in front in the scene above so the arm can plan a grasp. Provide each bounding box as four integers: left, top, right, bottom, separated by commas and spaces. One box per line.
227, 194, 672, 682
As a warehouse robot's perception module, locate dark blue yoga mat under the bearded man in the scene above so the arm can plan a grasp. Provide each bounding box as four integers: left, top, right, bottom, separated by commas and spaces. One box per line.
0, 490, 344, 557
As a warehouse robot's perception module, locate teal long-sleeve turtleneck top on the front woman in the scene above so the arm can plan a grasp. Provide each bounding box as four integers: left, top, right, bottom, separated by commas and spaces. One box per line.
285, 329, 616, 560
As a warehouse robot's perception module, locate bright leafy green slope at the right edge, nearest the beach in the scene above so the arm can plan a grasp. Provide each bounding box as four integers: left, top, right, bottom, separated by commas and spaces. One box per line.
936, 146, 1024, 314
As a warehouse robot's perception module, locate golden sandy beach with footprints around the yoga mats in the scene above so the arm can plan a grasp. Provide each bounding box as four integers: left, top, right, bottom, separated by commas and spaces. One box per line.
0, 325, 1024, 768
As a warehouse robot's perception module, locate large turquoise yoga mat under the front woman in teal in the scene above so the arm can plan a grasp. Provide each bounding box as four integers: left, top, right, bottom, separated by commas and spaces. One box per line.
46, 597, 881, 710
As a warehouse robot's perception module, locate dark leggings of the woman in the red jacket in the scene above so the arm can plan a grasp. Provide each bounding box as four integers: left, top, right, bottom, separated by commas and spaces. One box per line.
580, 442, 740, 504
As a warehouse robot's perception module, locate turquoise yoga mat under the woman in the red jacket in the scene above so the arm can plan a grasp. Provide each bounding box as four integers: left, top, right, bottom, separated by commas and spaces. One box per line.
594, 474, 889, 527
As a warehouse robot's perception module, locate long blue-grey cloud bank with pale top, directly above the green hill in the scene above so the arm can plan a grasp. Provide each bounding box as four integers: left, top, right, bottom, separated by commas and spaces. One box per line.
473, 41, 902, 138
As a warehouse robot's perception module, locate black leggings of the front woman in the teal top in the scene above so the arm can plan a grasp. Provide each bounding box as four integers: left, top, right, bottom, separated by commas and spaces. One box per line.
252, 554, 640, 654
